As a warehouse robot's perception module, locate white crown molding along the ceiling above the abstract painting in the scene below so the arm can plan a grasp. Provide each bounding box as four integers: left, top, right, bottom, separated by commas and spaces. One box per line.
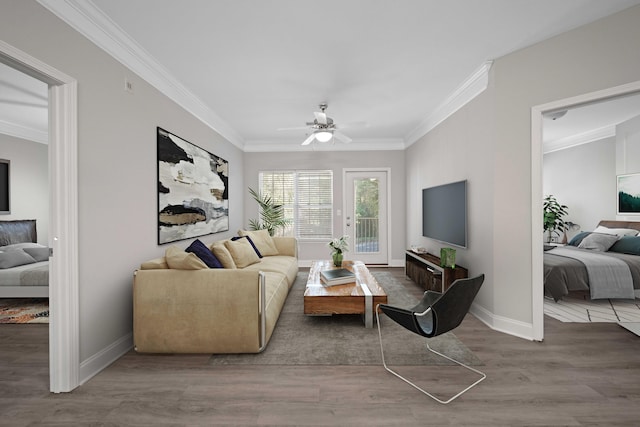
37, 0, 244, 150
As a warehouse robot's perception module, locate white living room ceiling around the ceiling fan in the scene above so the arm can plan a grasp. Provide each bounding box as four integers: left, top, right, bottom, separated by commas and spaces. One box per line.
0, 0, 640, 151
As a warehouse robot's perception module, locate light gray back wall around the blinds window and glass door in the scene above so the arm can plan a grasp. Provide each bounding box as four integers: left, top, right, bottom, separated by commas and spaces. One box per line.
244, 151, 407, 265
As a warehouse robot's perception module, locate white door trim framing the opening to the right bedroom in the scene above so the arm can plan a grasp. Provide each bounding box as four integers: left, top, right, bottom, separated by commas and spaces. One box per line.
531, 81, 640, 341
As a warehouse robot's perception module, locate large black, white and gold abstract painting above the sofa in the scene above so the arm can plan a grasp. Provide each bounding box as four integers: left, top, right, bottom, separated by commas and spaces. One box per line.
157, 127, 229, 245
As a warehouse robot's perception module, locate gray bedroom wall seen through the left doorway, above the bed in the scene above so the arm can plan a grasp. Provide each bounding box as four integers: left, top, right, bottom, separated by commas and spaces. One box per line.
0, 134, 49, 245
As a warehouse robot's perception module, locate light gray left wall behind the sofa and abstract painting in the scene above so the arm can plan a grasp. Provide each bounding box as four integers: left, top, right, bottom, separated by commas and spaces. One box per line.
0, 0, 245, 380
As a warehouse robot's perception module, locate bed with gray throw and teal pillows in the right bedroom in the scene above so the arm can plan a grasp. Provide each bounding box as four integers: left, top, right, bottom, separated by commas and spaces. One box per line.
544, 221, 640, 301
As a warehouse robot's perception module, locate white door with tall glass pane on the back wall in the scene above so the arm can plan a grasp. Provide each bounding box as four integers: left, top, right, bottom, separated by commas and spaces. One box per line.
343, 169, 389, 265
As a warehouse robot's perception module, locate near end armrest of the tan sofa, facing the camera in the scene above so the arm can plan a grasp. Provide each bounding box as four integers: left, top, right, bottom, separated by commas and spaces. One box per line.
133, 269, 265, 353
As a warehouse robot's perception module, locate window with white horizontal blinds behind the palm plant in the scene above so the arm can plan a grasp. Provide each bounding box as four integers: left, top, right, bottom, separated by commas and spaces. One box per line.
260, 170, 333, 240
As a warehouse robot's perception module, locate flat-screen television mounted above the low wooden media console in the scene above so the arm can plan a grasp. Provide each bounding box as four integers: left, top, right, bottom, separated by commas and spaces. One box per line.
422, 180, 467, 248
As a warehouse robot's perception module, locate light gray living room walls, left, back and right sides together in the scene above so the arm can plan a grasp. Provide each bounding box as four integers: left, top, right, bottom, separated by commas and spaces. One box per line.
0, 1, 640, 408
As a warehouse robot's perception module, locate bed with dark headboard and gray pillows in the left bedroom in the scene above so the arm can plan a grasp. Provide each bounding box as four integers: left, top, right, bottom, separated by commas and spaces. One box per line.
0, 219, 49, 298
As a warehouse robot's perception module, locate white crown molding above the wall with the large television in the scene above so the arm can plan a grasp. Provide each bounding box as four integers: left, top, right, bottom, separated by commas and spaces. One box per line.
405, 61, 493, 147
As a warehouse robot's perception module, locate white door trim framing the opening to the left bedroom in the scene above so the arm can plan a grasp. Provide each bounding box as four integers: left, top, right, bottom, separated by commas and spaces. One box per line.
0, 40, 80, 393
